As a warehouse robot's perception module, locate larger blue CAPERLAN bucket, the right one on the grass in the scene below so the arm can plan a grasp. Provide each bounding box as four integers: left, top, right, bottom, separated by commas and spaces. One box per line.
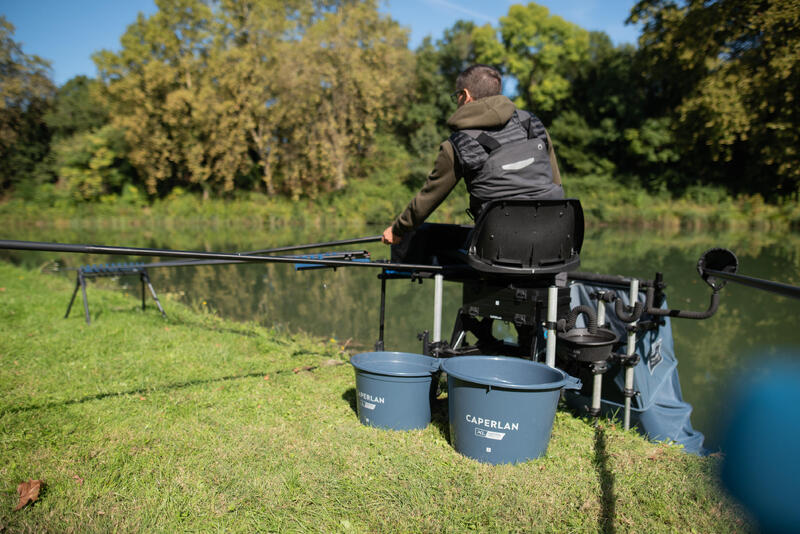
442, 356, 581, 464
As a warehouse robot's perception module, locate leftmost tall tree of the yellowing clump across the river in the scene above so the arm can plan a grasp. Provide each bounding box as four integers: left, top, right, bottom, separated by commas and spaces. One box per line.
94, 0, 216, 194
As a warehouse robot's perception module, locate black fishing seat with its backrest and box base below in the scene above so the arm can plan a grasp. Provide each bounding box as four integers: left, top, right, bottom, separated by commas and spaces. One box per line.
450, 199, 584, 358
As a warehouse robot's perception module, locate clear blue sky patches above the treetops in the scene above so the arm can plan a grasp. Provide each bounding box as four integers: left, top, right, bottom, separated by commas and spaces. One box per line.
0, 0, 638, 85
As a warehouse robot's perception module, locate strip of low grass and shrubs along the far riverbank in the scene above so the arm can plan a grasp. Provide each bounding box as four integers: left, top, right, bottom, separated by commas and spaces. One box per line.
0, 176, 800, 232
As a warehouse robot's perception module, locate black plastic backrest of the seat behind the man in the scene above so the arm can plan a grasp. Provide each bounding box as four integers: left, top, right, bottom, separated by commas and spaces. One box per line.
467, 198, 583, 276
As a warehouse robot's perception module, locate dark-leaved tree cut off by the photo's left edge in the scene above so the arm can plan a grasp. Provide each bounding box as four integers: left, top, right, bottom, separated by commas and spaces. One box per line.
0, 16, 55, 191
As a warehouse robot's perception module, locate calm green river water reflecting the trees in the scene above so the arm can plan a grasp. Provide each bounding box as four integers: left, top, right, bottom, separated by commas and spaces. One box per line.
0, 224, 800, 450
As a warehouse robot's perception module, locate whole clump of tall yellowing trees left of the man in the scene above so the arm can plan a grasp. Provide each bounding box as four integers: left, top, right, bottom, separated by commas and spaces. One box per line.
95, 0, 411, 197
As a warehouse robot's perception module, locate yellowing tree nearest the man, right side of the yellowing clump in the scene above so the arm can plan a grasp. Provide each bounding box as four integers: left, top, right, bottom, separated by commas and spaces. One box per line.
248, 1, 412, 197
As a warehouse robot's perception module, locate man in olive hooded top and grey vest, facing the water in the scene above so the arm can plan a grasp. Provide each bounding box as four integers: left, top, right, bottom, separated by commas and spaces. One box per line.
382, 65, 564, 245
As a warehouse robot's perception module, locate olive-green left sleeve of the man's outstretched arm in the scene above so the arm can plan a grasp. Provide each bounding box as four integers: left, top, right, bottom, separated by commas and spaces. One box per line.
392, 141, 458, 236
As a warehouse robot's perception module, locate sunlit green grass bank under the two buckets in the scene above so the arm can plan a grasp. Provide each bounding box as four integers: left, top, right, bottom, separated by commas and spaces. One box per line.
0, 264, 752, 533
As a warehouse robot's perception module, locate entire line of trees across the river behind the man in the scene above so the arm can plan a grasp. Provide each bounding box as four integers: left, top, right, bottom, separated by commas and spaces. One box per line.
0, 0, 800, 214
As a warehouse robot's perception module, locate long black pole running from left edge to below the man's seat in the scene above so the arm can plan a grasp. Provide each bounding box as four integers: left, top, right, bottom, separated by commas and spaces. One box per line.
0, 239, 444, 272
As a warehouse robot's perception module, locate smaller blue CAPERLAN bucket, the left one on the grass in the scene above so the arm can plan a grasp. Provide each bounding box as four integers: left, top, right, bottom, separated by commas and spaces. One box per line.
350, 352, 440, 430
